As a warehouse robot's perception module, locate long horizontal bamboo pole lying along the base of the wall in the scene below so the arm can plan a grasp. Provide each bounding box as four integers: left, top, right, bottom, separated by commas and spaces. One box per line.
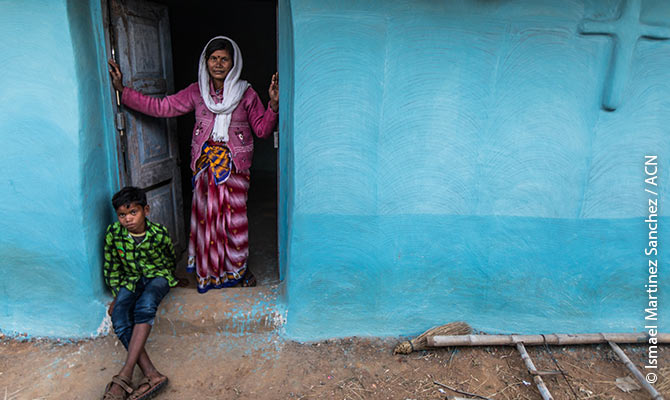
427, 333, 670, 347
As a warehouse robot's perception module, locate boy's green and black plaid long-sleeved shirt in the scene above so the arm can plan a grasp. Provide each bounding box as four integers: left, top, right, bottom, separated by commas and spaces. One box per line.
103, 220, 177, 297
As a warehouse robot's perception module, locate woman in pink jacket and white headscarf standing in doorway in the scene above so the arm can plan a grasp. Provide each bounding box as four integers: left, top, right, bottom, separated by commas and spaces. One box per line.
109, 36, 279, 293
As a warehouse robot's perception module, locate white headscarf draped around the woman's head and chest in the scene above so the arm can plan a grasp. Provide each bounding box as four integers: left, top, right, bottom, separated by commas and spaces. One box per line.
198, 36, 249, 142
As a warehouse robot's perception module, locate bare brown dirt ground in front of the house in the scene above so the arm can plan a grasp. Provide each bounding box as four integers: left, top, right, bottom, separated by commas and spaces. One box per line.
0, 331, 670, 400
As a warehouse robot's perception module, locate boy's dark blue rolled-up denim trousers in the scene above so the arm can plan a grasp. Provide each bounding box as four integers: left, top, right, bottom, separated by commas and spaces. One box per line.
112, 276, 170, 350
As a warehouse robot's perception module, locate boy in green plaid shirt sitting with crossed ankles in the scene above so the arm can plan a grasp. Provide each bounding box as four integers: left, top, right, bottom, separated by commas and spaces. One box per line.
103, 187, 177, 400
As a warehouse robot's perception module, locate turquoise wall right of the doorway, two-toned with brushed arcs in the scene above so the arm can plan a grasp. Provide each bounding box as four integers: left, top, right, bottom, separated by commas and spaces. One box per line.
280, 0, 670, 339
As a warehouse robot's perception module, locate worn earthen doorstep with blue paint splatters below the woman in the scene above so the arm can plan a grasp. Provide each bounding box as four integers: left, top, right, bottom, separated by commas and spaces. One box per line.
152, 285, 284, 336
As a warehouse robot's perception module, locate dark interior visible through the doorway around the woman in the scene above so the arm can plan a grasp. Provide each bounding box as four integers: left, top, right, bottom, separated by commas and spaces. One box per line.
154, 0, 279, 285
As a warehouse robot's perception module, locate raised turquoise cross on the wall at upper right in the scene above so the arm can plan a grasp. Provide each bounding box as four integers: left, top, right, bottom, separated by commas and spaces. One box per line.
578, 0, 670, 111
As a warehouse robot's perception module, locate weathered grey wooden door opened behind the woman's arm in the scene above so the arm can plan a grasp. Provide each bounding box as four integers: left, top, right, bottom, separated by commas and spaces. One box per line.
109, 0, 186, 254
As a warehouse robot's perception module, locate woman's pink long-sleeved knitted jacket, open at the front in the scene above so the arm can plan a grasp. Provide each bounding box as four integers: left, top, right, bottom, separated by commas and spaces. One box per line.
121, 83, 277, 170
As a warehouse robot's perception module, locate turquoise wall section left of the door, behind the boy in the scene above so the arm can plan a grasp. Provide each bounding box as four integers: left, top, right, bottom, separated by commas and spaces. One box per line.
0, 0, 118, 337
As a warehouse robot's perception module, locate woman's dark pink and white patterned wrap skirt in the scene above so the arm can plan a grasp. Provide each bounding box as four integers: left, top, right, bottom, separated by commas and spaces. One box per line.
187, 168, 249, 293
